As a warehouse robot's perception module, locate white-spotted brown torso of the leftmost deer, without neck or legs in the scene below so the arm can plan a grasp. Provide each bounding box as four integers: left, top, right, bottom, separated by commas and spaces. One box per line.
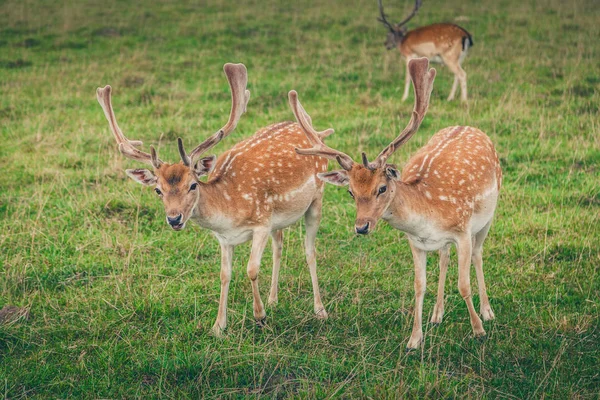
207, 121, 327, 224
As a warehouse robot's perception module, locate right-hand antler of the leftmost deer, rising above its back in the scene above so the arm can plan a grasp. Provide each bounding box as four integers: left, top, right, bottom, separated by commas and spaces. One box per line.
189, 63, 250, 163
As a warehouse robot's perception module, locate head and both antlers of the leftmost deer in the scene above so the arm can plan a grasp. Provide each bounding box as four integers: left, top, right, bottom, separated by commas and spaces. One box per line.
96, 64, 250, 230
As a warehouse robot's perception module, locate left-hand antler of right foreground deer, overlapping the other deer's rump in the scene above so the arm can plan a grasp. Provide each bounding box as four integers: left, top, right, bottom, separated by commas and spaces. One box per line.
288, 90, 354, 171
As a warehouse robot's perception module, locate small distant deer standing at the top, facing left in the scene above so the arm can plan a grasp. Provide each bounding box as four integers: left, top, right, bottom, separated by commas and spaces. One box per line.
377, 0, 473, 102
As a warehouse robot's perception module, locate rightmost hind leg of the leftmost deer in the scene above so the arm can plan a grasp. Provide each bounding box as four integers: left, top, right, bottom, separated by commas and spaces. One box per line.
304, 197, 327, 319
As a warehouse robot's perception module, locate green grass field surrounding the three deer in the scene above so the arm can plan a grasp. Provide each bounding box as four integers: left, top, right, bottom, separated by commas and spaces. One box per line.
0, 0, 600, 399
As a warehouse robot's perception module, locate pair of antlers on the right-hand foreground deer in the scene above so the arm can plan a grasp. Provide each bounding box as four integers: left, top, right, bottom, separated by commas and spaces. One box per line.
288, 58, 436, 171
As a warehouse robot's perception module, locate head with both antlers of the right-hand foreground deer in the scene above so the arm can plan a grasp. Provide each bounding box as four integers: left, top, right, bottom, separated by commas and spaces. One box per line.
289, 58, 436, 234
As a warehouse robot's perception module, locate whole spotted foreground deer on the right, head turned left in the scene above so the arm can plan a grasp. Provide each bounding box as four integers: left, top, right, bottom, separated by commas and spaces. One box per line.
289, 58, 502, 350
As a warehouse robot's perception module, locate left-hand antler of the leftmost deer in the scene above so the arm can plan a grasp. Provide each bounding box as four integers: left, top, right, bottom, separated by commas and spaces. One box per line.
96, 85, 163, 169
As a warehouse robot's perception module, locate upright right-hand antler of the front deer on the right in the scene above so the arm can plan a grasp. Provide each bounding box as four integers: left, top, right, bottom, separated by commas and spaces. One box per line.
363, 57, 436, 170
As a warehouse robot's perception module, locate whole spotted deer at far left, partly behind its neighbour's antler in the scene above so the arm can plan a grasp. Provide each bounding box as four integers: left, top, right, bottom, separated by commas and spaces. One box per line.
97, 64, 333, 336
